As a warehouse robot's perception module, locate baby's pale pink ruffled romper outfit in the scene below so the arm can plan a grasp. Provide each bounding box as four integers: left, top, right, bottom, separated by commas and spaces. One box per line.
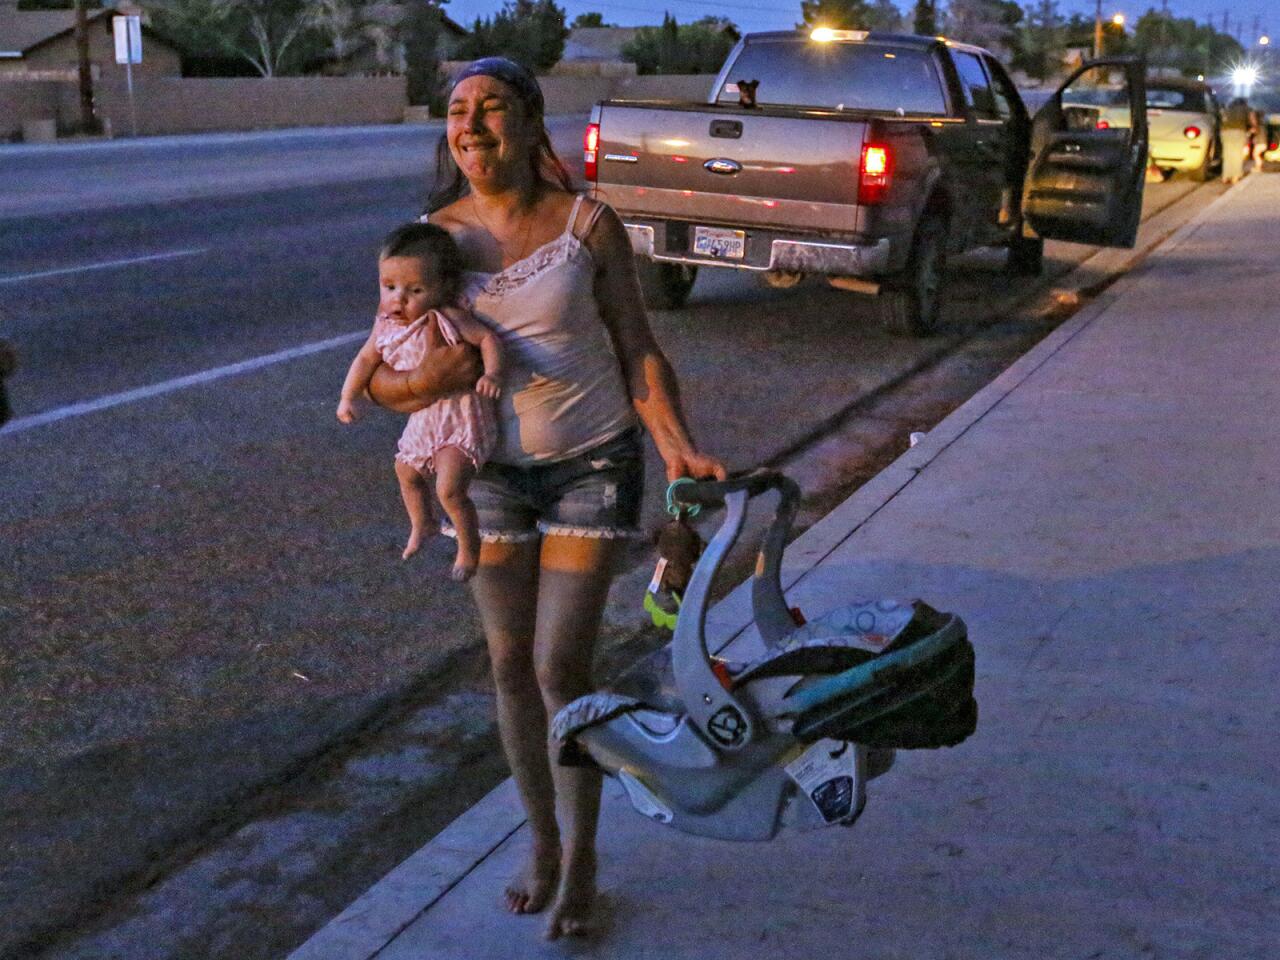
374, 310, 498, 474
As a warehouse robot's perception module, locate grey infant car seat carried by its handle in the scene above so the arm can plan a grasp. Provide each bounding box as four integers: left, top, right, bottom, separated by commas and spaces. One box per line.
552, 470, 977, 840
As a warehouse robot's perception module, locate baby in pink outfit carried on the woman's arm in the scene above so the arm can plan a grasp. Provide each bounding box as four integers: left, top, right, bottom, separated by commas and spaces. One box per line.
338, 223, 502, 581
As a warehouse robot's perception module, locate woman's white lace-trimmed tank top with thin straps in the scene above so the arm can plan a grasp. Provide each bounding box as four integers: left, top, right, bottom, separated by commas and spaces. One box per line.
463, 196, 636, 466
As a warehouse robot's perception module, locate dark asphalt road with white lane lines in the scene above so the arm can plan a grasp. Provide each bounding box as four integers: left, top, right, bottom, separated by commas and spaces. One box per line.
0, 119, 1193, 955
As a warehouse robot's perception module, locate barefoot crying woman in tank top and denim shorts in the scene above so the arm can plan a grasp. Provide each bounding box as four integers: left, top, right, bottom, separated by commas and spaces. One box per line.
372, 58, 724, 938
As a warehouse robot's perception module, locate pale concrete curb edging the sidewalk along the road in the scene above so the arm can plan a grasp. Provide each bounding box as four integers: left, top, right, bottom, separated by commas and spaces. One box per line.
288, 172, 1251, 960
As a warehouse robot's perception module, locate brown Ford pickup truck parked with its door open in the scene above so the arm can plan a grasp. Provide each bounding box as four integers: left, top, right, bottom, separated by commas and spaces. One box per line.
584, 29, 1147, 335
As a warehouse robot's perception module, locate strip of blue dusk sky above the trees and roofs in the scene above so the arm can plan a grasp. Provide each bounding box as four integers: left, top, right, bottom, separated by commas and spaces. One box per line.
444, 0, 1280, 47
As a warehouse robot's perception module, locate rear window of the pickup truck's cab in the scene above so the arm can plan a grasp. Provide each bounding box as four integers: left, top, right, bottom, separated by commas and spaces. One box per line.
716, 40, 947, 115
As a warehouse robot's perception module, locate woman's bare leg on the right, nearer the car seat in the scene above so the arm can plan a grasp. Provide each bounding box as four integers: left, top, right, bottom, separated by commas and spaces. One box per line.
534, 536, 618, 940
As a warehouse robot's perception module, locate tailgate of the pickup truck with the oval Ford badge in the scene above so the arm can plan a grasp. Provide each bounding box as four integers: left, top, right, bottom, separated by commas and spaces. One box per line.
598, 101, 867, 233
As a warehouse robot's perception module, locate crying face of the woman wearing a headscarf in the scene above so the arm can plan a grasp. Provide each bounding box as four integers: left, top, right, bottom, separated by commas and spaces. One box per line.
445, 76, 535, 186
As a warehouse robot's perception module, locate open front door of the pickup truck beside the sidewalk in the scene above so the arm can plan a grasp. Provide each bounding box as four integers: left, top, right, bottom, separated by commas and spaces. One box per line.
1023, 58, 1147, 247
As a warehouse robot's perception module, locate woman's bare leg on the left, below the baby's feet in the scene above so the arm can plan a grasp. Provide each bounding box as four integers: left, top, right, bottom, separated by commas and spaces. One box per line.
471, 539, 561, 914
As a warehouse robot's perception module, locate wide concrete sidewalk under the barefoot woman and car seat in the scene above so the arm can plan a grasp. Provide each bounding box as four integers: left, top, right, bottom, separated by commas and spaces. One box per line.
293, 177, 1280, 960
